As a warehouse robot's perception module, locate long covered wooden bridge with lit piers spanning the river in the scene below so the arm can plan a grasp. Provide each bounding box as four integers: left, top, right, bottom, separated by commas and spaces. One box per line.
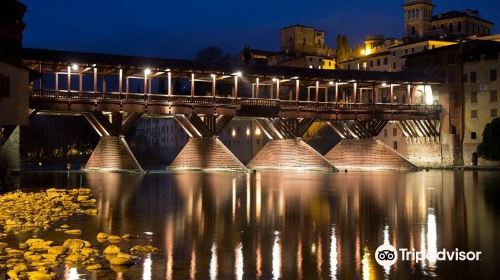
24, 49, 441, 171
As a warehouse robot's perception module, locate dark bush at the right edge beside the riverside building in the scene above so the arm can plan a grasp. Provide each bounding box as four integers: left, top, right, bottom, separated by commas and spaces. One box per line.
477, 118, 500, 160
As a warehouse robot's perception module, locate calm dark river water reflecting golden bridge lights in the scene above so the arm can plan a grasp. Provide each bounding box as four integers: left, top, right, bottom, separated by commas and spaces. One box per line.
0, 171, 500, 279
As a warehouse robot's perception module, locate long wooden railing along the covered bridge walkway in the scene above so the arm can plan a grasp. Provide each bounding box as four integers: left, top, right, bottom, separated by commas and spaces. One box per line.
30, 89, 442, 113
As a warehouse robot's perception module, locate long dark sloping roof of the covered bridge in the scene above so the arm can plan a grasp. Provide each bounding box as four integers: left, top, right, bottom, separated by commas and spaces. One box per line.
23, 48, 442, 84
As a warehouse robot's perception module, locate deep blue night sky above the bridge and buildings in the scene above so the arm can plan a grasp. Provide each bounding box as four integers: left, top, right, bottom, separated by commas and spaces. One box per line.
23, 0, 500, 59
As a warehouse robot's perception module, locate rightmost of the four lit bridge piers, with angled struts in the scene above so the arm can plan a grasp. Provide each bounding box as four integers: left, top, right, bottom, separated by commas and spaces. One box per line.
325, 120, 420, 171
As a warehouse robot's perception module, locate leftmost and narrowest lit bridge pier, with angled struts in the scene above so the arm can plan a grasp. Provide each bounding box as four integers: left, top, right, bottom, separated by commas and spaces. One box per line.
84, 112, 143, 173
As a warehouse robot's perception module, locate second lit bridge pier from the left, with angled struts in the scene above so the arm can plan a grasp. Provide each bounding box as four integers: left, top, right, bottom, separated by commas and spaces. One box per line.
169, 114, 248, 172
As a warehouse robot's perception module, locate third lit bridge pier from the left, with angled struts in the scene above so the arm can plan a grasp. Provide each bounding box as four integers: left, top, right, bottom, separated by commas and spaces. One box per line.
247, 118, 337, 171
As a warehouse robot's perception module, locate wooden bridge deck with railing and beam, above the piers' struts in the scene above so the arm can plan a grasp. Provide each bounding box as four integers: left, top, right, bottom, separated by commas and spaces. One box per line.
30, 90, 441, 120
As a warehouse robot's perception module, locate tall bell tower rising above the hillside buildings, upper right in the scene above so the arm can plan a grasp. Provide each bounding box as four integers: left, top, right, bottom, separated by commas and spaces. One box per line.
403, 0, 434, 38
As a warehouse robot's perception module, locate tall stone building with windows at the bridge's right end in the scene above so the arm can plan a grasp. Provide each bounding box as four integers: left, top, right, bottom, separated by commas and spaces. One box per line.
406, 40, 500, 165
